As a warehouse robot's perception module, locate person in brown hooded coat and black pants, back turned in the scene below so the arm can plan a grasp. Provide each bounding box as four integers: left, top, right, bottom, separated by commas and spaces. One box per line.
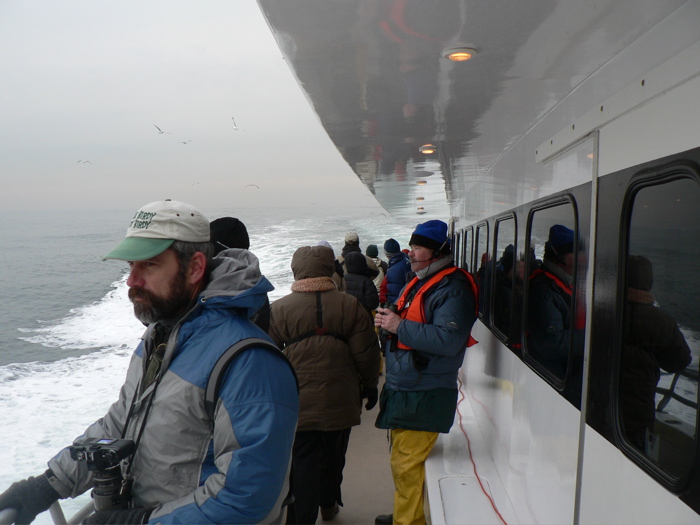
270, 246, 379, 523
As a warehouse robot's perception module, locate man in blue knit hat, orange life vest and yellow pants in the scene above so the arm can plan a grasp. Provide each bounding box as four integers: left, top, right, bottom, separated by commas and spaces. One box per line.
374, 220, 478, 524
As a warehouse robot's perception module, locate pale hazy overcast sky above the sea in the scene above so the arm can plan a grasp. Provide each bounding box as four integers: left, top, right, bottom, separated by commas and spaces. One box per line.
0, 0, 378, 210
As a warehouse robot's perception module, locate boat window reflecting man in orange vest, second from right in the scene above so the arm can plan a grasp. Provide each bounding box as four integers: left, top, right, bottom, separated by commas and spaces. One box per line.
518, 201, 586, 407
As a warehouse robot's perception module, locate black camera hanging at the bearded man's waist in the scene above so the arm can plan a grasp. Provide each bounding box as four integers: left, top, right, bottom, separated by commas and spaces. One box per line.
70, 438, 136, 510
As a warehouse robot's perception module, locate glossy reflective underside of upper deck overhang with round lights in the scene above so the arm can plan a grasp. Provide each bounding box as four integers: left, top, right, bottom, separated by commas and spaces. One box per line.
259, 0, 697, 221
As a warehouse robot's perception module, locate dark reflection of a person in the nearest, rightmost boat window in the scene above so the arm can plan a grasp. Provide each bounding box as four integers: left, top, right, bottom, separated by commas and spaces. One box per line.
620, 255, 691, 450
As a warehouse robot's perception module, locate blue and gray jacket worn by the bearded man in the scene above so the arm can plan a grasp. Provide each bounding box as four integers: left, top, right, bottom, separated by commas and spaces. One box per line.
49, 250, 298, 524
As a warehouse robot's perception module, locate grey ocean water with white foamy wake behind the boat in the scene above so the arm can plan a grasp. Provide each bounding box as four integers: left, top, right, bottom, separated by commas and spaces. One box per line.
0, 207, 418, 523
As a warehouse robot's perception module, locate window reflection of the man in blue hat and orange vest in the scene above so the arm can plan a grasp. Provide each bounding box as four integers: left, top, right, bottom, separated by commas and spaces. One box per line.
527, 224, 585, 407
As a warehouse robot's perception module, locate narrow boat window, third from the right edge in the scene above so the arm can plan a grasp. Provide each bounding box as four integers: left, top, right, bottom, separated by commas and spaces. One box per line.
493, 216, 522, 340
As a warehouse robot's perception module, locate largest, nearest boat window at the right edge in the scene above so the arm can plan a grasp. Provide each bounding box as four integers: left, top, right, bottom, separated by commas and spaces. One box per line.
618, 178, 700, 478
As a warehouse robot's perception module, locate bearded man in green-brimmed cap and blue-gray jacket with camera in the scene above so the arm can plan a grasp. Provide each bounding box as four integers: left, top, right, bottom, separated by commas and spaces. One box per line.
0, 200, 298, 524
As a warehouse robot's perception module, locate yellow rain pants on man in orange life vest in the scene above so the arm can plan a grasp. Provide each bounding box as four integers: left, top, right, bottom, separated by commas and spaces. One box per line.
391, 429, 438, 525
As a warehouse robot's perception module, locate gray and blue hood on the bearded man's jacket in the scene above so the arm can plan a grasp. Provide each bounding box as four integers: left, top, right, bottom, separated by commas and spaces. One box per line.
199, 248, 275, 316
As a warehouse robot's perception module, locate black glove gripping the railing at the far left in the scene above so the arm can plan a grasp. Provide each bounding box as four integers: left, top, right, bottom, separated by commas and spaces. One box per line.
0, 470, 61, 524
